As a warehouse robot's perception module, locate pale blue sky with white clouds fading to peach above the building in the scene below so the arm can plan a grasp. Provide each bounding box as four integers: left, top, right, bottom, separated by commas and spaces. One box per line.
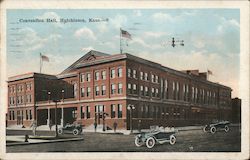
7, 9, 240, 97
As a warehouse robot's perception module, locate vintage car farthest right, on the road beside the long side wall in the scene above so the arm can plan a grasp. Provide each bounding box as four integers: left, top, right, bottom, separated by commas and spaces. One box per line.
203, 121, 230, 134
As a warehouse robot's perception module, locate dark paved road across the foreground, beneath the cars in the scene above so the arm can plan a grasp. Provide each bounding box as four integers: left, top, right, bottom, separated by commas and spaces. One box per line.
7, 127, 241, 152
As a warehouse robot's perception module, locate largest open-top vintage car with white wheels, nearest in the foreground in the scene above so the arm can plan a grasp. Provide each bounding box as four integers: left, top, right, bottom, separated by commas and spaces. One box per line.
135, 130, 176, 148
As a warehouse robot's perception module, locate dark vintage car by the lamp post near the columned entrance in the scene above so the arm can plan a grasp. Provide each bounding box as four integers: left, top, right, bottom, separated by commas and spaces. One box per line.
58, 124, 82, 135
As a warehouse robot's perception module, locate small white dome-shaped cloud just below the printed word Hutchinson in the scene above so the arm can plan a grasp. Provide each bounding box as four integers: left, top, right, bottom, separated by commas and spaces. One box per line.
74, 27, 96, 40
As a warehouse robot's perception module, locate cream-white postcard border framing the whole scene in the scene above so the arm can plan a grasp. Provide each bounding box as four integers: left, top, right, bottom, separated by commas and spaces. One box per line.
0, 0, 249, 160
